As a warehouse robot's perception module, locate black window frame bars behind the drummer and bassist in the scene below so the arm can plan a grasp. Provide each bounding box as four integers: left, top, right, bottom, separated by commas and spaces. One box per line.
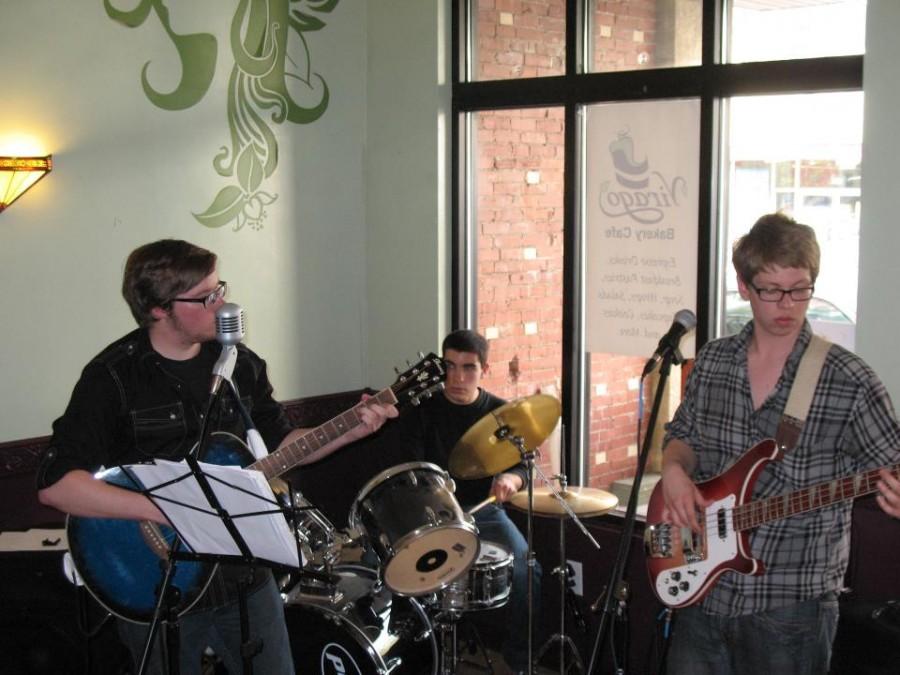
450, 0, 864, 485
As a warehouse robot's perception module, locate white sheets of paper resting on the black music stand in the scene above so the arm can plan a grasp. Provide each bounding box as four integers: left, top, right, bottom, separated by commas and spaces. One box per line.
123, 459, 301, 567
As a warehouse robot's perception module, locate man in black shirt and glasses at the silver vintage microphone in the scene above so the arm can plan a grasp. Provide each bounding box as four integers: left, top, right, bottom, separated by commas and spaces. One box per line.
38, 239, 397, 675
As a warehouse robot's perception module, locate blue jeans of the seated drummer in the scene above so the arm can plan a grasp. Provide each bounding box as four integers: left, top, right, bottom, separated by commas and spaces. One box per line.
474, 504, 541, 670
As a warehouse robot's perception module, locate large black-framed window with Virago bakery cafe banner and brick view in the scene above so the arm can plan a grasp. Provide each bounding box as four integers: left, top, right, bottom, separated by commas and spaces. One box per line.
452, 0, 865, 492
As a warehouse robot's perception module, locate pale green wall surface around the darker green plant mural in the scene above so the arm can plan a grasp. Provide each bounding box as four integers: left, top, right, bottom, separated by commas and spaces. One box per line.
0, 0, 449, 441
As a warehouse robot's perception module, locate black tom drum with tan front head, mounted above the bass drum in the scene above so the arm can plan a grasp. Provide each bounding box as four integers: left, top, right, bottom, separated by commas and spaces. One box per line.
349, 462, 478, 595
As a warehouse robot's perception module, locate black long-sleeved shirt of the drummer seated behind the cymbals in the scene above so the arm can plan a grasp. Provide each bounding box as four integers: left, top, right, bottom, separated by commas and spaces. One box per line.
382, 389, 526, 509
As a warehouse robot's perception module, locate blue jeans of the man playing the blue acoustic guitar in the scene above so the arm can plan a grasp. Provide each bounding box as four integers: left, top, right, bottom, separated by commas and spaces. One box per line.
118, 572, 294, 675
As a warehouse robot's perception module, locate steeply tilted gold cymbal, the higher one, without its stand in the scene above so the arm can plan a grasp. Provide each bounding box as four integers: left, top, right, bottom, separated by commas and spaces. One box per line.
449, 394, 560, 478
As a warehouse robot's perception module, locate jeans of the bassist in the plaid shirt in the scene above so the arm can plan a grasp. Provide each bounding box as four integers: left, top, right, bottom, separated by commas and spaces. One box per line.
666, 593, 838, 675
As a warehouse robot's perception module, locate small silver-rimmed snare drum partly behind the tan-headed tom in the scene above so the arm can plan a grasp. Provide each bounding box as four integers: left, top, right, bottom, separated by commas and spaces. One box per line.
436, 541, 514, 612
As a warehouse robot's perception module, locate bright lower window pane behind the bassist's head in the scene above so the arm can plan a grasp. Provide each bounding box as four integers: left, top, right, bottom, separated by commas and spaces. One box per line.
720, 92, 863, 349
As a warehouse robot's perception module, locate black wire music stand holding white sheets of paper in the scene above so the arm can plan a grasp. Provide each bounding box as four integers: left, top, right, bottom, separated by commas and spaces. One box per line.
122, 455, 301, 675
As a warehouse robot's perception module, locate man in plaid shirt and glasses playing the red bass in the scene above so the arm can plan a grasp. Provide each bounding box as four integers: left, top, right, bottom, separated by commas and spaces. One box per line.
662, 213, 900, 675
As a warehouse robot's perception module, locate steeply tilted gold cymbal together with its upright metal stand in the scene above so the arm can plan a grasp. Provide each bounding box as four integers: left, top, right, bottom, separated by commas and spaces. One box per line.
449, 394, 561, 675
